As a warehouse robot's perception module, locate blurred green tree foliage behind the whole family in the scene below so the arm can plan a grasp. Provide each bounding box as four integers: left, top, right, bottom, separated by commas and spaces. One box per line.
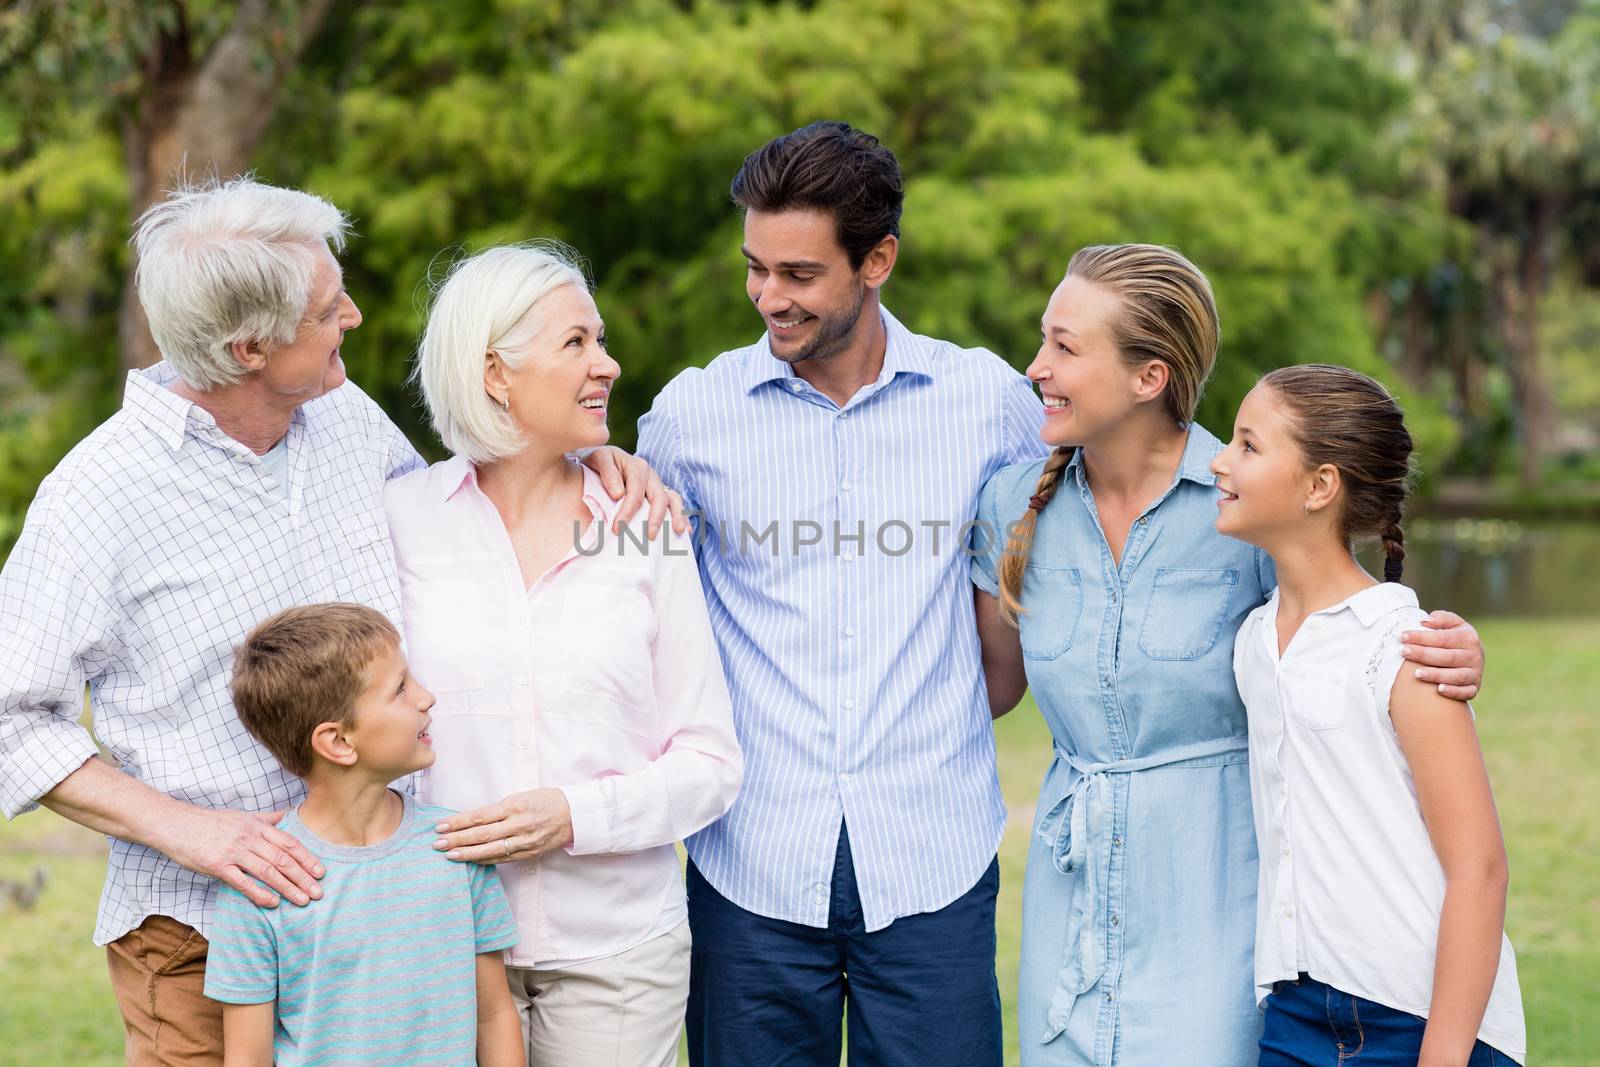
0, 0, 1600, 550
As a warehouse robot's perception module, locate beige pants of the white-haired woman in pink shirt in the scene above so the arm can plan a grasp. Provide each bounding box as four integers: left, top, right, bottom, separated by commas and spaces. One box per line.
506, 921, 690, 1067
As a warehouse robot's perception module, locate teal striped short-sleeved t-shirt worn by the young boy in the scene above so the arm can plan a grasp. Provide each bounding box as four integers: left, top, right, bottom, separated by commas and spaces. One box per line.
205, 793, 517, 1067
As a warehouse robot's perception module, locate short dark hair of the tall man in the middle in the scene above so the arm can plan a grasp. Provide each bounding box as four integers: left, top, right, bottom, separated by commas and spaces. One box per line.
730, 122, 906, 270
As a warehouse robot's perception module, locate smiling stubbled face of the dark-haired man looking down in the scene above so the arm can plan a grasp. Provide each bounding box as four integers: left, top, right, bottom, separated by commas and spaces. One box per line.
741, 211, 870, 363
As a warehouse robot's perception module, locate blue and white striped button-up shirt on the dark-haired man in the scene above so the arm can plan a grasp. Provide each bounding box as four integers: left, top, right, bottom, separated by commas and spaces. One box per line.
638, 303, 1046, 931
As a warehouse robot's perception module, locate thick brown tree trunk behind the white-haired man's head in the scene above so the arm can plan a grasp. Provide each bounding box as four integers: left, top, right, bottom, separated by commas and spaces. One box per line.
117, 0, 340, 375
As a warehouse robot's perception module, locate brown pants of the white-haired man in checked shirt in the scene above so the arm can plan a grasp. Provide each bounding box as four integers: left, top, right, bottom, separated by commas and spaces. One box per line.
106, 915, 222, 1067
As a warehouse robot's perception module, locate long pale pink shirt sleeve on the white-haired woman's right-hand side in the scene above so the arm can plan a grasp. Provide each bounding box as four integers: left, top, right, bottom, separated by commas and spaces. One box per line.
562, 537, 744, 856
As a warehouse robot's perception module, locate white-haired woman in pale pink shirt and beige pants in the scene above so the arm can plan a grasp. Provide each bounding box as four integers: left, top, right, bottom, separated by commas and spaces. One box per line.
384, 245, 742, 1067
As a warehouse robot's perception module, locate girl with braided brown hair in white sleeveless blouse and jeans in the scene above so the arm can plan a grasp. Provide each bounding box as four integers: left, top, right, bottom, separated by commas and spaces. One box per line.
1211, 363, 1526, 1067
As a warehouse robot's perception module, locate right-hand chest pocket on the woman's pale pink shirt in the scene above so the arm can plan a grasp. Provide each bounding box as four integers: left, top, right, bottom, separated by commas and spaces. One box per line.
557, 585, 656, 729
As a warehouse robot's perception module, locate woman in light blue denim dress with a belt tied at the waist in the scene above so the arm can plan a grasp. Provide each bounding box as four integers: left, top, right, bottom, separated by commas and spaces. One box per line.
973, 245, 1482, 1067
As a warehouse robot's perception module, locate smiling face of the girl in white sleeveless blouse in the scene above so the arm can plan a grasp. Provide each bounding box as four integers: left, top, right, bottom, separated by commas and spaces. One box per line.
1211, 386, 1336, 552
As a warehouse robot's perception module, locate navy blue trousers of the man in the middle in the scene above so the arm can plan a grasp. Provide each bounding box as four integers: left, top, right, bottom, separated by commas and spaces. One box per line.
686, 827, 1003, 1067
